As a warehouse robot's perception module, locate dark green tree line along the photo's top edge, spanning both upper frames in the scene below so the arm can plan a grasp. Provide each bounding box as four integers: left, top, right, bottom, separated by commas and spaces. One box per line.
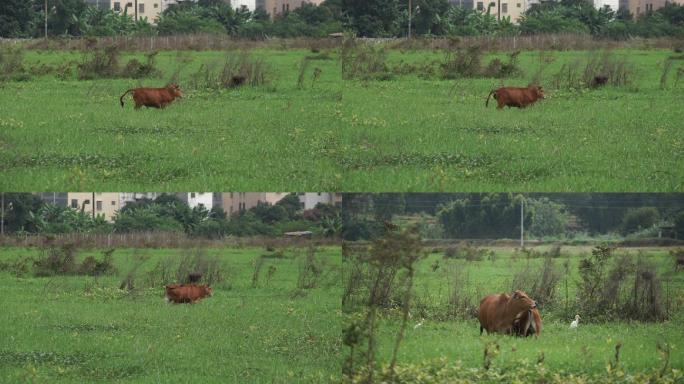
0, 0, 684, 39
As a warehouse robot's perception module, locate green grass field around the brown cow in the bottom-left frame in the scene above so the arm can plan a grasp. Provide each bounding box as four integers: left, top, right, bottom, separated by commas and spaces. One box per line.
0, 244, 341, 383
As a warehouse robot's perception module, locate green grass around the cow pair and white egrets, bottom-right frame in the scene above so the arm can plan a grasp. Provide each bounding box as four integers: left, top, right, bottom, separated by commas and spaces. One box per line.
346, 247, 684, 376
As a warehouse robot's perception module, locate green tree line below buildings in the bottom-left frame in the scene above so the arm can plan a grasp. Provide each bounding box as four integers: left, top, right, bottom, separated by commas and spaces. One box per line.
4, 193, 341, 239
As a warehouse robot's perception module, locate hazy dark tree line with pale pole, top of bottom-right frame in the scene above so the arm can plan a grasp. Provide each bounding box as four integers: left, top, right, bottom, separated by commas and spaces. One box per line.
342, 193, 684, 240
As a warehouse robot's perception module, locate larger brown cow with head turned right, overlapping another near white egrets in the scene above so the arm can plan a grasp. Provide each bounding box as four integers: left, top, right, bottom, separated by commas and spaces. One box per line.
477, 290, 537, 334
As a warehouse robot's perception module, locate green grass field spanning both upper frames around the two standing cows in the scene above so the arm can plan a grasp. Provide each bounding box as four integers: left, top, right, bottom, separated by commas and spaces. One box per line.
0, 49, 684, 192
